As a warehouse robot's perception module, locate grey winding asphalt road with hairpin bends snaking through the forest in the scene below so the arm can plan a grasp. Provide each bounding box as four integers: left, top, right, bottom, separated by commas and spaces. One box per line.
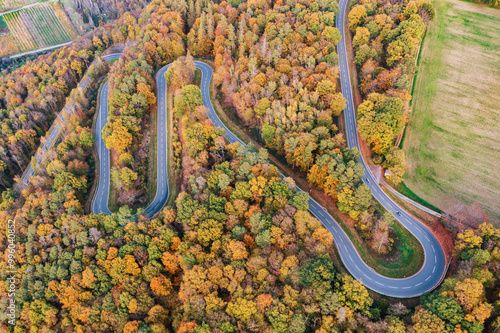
92, 53, 446, 298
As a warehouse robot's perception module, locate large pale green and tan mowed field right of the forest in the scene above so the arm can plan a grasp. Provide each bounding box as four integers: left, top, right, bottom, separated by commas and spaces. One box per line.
404, 0, 500, 226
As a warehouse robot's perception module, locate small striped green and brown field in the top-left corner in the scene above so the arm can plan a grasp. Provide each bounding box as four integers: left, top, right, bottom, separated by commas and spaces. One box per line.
0, 2, 78, 56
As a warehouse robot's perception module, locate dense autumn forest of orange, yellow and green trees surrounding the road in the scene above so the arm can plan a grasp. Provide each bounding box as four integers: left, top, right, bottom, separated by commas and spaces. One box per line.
0, 0, 500, 333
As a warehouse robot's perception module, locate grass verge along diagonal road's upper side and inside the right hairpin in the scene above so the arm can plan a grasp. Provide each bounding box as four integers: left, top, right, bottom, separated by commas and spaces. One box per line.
205, 61, 424, 278
